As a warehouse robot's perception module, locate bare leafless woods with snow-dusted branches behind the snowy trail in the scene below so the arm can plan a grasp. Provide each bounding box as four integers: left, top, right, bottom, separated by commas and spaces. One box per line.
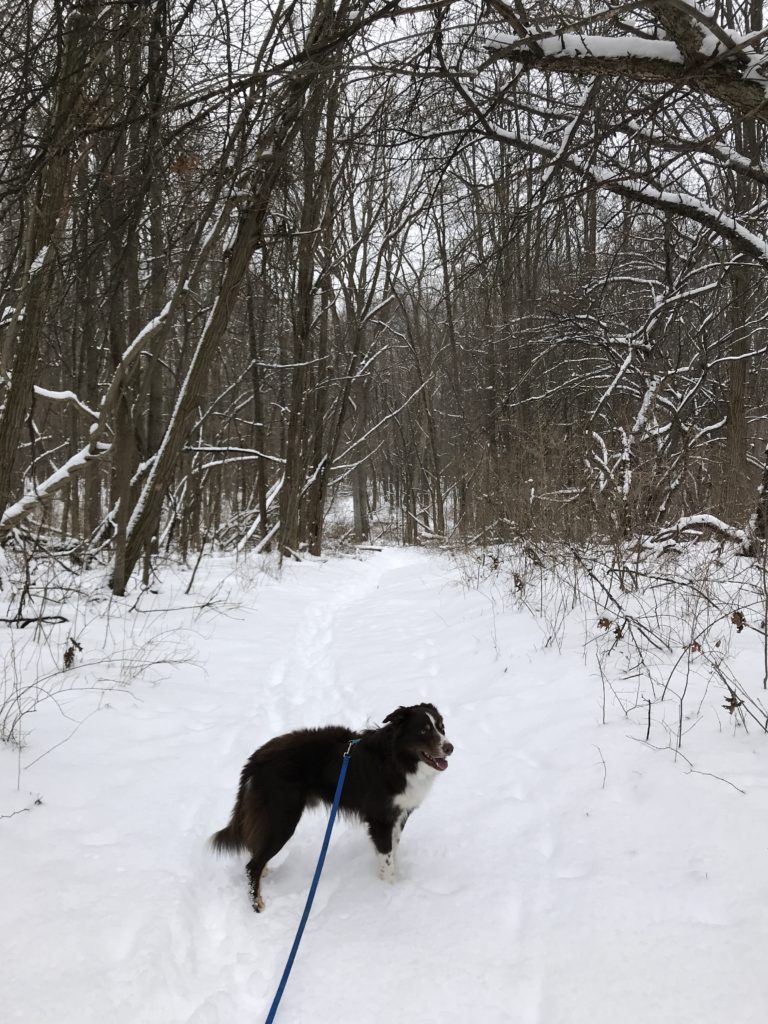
0, 0, 768, 594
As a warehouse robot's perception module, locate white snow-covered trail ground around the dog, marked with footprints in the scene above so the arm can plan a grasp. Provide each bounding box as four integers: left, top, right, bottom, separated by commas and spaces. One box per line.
0, 549, 768, 1024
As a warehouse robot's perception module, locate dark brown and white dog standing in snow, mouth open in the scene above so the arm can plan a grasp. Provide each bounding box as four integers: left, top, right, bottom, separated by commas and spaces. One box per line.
210, 703, 454, 913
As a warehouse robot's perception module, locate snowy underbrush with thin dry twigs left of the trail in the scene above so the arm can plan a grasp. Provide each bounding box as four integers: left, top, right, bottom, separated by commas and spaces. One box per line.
0, 551, 228, 749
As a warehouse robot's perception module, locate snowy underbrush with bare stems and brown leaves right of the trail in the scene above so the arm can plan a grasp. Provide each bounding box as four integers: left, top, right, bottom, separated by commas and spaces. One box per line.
457, 543, 768, 751
